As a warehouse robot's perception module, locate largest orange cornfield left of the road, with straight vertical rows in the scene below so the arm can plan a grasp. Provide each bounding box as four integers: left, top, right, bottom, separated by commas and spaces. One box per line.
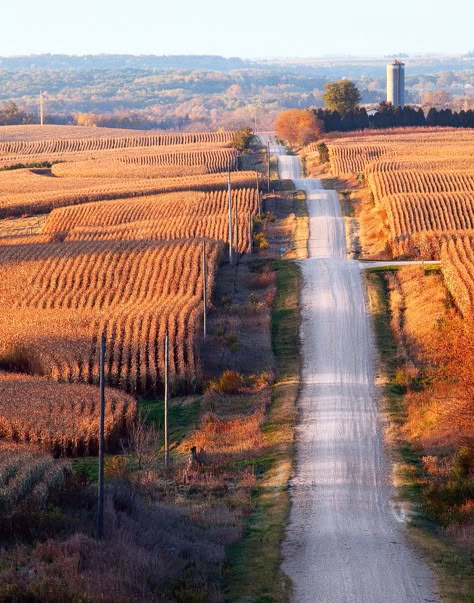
0, 240, 224, 392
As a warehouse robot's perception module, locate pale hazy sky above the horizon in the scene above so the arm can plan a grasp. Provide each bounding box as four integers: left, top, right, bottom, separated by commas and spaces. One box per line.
0, 0, 474, 57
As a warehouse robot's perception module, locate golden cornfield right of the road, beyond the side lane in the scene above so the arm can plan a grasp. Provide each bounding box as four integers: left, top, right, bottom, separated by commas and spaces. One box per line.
329, 130, 474, 258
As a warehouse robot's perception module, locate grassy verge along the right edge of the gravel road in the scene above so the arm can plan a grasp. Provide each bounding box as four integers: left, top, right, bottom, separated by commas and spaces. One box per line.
365, 271, 474, 603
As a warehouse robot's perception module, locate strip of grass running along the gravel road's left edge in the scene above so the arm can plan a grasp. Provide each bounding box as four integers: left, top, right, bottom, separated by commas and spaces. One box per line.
227, 261, 300, 603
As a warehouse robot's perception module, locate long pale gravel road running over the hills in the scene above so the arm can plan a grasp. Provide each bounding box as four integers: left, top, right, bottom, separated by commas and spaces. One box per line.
272, 143, 438, 603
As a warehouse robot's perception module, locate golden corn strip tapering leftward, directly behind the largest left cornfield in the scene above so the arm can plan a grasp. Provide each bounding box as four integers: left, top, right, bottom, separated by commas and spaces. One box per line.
42, 188, 258, 253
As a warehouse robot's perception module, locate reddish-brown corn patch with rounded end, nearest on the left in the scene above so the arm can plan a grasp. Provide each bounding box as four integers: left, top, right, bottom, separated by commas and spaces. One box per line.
0, 372, 136, 456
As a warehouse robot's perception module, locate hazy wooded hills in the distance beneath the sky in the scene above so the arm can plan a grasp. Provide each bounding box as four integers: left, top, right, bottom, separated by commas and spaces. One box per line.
0, 55, 474, 130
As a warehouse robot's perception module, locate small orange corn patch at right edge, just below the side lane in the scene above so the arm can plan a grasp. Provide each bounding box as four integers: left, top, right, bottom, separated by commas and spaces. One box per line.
441, 233, 474, 318
